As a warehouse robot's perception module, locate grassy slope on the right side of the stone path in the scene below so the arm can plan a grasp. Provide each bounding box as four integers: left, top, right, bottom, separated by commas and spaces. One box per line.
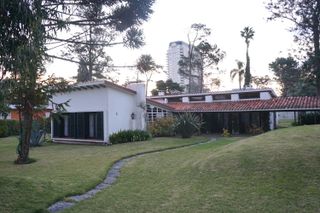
66, 125, 320, 212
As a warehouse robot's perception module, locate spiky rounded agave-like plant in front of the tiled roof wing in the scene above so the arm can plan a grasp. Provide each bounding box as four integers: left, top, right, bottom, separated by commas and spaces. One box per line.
175, 112, 203, 138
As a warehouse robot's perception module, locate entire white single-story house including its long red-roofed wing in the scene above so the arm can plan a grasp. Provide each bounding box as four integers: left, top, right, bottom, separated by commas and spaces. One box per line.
52, 80, 320, 143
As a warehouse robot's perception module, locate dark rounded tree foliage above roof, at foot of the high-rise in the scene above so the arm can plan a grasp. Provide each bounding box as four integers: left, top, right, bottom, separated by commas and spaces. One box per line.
151, 79, 184, 96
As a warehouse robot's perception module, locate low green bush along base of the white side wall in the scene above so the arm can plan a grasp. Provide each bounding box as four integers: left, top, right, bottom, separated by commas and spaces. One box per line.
109, 130, 151, 144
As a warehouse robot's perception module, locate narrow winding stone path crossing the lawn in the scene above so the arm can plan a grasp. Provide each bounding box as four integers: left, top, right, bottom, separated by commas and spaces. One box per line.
48, 138, 216, 213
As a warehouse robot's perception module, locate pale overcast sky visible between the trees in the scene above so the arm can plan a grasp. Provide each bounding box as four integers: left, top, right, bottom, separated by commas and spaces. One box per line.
47, 0, 294, 90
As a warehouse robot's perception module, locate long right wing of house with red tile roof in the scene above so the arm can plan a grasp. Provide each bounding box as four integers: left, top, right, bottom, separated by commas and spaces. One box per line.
147, 88, 320, 133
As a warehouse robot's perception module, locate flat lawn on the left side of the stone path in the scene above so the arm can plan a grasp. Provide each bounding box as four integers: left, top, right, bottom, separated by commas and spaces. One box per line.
0, 137, 205, 213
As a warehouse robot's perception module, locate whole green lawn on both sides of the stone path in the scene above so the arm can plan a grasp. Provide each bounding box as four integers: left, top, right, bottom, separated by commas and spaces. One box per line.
0, 125, 320, 213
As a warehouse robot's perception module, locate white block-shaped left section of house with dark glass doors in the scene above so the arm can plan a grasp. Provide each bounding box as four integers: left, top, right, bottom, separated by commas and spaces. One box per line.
51, 81, 146, 143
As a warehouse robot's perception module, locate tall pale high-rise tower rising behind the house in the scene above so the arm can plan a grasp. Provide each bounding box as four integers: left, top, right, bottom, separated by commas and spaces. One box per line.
167, 41, 200, 92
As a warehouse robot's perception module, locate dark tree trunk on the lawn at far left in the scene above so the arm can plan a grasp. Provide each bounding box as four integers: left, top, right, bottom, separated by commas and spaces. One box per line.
16, 106, 33, 164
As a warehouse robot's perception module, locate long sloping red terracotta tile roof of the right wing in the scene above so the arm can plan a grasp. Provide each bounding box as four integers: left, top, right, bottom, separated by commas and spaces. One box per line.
168, 97, 320, 112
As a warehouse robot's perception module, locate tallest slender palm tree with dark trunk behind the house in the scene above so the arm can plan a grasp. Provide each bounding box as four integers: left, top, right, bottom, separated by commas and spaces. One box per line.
241, 27, 254, 86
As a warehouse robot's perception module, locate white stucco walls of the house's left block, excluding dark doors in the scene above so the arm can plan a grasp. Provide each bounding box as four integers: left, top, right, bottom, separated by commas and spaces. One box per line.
53, 87, 141, 142
